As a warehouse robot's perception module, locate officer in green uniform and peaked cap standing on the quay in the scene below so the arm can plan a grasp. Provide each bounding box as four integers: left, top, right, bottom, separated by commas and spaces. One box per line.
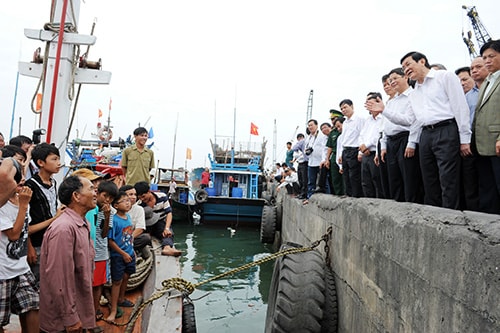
326, 109, 345, 195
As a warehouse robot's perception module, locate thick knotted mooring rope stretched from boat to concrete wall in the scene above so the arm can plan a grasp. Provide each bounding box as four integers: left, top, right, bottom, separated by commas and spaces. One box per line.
108, 227, 332, 332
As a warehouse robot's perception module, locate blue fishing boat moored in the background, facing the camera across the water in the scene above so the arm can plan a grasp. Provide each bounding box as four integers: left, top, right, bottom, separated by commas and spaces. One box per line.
195, 137, 266, 226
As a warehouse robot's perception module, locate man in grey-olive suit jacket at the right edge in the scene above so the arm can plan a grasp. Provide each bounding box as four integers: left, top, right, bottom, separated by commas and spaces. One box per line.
473, 40, 500, 214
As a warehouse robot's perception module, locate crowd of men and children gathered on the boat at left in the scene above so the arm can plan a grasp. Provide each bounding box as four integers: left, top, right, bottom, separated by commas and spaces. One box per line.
0, 127, 181, 333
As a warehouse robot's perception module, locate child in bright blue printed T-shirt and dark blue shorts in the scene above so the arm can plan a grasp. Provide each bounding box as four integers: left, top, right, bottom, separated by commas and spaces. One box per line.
106, 191, 135, 321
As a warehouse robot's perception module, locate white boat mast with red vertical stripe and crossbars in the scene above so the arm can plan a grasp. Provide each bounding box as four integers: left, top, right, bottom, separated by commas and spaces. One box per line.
19, 0, 111, 164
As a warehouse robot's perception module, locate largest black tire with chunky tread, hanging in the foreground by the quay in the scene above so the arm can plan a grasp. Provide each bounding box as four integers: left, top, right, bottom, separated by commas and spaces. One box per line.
266, 246, 325, 333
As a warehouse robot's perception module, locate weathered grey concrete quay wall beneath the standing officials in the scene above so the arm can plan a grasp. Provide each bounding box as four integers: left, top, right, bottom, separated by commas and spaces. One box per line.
279, 194, 500, 333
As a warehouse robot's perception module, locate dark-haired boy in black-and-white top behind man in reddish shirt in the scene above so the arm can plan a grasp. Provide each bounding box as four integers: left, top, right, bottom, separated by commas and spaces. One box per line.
26, 143, 64, 282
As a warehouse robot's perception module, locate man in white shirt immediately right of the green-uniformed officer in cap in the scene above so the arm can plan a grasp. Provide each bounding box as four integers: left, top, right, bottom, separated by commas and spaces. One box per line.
339, 99, 364, 198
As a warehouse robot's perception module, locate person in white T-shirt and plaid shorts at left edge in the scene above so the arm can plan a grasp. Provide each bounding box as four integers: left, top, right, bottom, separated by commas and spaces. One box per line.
0, 148, 39, 333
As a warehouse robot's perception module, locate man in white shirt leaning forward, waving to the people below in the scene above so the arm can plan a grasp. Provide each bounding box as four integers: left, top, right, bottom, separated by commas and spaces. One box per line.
369, 52, 471, 209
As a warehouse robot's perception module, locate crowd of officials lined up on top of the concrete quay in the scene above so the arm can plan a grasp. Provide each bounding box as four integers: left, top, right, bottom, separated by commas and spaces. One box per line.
273, 40, 500, 214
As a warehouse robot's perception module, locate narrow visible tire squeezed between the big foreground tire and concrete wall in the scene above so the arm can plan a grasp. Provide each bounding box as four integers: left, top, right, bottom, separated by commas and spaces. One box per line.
321, 267, 339, 333
